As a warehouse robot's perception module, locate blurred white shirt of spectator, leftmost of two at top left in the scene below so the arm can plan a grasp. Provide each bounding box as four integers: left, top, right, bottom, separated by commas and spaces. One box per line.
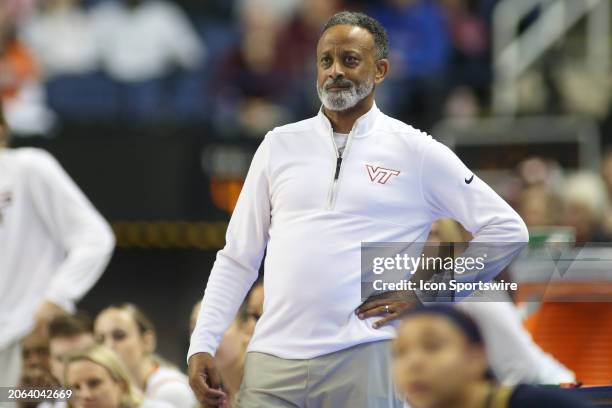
22, 0, 99, 79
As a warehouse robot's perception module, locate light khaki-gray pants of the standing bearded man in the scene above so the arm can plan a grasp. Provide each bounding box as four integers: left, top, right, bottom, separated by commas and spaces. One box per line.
233, 341, 403, 408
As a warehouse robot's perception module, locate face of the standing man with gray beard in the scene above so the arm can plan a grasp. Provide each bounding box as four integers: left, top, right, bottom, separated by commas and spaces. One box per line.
317, 25, 388, 111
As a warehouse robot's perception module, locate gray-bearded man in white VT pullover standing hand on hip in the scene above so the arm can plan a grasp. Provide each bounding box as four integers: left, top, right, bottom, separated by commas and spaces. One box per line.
188, 12, 527, 408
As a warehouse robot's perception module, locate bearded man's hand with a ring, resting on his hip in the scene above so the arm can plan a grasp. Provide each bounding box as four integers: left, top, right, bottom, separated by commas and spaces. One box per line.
355, 291, 421, 329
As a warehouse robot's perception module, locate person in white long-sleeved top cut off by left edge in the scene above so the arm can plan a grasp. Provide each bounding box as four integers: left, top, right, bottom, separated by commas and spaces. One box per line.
0, 100, 115, 386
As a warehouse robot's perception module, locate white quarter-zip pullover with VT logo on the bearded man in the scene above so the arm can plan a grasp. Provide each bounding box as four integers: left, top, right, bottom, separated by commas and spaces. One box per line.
188, 105, 528, 359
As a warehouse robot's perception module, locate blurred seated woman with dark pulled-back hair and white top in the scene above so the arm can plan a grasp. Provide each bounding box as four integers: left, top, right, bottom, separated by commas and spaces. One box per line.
94, 304, 197, 408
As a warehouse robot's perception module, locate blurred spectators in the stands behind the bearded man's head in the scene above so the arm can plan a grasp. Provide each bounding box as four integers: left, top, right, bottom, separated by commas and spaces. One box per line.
0, 0, 504, 137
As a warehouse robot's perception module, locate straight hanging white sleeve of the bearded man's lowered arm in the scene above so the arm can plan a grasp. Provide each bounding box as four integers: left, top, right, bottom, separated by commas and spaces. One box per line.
187, 135, 271, 361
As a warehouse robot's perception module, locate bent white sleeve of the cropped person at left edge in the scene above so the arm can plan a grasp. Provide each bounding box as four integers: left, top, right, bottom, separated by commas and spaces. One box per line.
27, 151, 115, 312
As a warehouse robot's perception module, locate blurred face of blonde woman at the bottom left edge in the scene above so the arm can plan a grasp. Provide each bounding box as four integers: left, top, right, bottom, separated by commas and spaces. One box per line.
66, 360, 125, 408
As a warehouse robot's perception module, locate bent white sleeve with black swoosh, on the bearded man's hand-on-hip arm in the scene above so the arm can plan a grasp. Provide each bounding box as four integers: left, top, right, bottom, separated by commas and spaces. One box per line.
421, 140, 529, 296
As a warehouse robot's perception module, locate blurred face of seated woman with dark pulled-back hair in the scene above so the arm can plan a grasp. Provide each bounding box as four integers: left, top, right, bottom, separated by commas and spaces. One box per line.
94, 308, 155, 374
